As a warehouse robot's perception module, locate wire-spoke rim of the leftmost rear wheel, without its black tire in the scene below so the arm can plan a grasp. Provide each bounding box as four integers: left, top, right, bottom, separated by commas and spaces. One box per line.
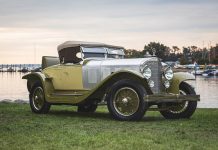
32, 87, 45, 110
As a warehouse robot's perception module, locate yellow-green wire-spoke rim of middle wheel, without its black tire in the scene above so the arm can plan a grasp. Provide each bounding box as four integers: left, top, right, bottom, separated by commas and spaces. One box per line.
113, 87, 140, 116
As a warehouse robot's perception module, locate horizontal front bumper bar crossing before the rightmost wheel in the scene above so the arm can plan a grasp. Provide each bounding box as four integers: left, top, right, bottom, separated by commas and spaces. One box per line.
144, 94, 200, 103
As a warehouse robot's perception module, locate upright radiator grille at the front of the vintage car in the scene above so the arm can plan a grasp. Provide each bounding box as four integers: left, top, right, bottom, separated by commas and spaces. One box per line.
146, 59, 162, 93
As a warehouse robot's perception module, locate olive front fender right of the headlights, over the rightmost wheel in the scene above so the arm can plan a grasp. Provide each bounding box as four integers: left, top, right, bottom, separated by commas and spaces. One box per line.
168, 72, 195, 94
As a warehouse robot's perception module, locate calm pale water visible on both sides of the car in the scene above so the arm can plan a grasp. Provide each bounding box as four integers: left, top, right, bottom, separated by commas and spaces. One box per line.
0, 72, 218, 108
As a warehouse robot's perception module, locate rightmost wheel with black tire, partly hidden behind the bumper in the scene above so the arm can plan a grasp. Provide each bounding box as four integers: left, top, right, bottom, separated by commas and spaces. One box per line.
158, 82, 197, 119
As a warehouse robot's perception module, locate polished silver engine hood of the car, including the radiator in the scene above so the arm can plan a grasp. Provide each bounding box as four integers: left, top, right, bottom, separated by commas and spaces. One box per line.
82, 57, 163, 93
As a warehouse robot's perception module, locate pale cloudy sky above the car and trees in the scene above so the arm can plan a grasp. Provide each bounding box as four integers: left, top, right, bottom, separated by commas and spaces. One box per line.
0, 0, 218, 64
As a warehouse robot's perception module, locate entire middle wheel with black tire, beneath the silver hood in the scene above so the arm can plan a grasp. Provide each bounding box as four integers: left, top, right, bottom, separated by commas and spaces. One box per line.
106, 79, 148, 121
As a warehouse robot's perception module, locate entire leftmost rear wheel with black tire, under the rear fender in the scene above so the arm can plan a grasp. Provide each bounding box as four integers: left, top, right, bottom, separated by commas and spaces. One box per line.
29, 82, 51, 114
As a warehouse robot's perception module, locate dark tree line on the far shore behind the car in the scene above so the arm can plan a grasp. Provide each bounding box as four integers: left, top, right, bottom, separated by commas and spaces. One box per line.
125, 42, 218, 65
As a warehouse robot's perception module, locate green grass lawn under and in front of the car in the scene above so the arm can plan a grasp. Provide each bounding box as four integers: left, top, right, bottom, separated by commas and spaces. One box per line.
0, 103, 218, 150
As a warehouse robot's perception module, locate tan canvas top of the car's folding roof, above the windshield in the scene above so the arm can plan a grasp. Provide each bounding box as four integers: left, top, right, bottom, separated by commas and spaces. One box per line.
58, 41, 124, 51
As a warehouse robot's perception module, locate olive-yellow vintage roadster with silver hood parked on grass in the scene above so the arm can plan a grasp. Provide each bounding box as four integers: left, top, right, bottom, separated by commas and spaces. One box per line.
23, 41, 200, 120
